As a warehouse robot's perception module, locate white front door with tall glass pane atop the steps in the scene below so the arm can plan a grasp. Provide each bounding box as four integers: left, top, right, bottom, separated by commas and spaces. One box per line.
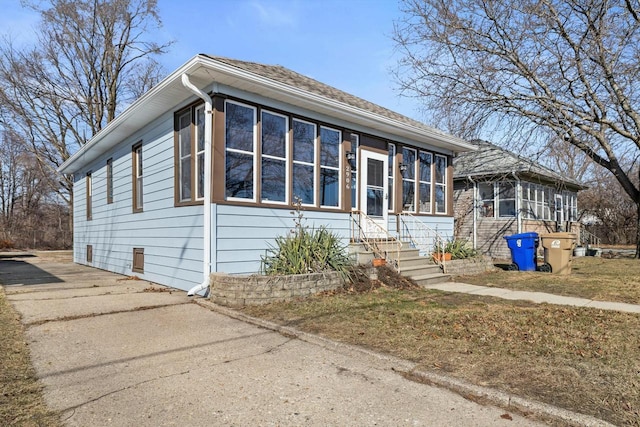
360, 150, 389, 238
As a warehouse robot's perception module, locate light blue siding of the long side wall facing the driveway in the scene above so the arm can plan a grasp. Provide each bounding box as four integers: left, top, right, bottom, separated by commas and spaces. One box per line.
74, 113, 203, 290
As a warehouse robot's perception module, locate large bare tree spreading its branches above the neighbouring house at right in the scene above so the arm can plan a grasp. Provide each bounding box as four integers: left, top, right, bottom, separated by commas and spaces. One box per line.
394, 0, 640, 258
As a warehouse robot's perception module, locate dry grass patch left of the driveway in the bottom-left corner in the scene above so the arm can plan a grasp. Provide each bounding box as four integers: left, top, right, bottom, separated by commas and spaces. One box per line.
0, 288, 61, 427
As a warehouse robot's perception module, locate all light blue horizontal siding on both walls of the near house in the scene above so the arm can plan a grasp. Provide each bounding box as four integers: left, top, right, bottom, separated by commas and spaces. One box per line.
74, 88, 453, 290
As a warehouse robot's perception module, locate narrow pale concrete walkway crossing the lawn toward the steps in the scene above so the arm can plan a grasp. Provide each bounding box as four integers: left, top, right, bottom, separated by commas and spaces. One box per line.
425, 282, 640, 313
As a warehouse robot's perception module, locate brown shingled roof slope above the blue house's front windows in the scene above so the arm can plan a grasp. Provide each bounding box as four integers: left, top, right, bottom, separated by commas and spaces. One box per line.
204, 55, 445, 139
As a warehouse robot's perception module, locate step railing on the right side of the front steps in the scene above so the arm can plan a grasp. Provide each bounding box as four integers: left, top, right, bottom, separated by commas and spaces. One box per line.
399, 212, 447, 269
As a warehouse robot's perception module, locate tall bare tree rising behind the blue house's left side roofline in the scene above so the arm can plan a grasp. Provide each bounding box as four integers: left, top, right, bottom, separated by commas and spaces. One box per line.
0, 0, 170, 205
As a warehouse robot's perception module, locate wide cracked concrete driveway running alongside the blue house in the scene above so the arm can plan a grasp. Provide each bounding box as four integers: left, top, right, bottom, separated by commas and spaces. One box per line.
0, 253, 537, 426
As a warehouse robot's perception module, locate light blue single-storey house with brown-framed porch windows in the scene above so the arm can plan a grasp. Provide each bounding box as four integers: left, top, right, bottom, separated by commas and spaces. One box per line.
59, 55, 473, 290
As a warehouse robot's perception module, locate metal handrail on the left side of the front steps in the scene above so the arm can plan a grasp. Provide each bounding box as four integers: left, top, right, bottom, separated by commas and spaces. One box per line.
351, 210, 402, 271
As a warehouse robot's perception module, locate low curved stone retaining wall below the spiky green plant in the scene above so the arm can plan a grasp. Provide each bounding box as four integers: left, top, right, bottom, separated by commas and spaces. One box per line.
209, 272, 344, 307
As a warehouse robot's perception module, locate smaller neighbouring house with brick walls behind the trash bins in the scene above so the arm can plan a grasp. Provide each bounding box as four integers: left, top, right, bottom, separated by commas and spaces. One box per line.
454, 141, 586, 258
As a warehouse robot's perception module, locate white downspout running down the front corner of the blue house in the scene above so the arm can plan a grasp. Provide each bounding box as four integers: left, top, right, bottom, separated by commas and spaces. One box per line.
182, 74, 213, 297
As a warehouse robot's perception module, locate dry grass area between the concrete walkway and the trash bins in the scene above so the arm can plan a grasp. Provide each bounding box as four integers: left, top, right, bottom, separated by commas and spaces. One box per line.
454, 257, 640, 304
